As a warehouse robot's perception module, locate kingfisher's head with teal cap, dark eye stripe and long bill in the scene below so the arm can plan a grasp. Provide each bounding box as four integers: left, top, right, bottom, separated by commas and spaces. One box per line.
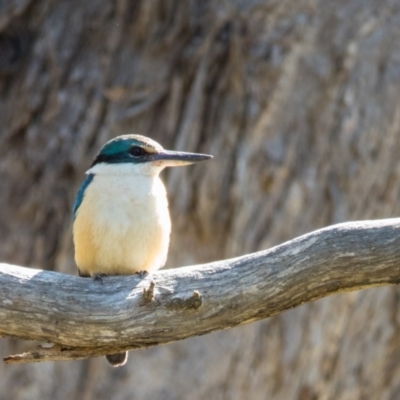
88, 134, 212, 175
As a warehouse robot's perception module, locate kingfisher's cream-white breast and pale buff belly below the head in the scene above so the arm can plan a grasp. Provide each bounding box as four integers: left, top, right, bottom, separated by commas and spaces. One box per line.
74, 170, 171, 275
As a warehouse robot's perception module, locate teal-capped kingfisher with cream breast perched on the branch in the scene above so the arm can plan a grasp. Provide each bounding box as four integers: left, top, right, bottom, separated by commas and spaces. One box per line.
73, 134, 212, 367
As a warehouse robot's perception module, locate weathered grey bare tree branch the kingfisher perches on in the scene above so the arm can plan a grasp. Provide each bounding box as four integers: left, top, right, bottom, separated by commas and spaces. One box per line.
0, 219, 400, 363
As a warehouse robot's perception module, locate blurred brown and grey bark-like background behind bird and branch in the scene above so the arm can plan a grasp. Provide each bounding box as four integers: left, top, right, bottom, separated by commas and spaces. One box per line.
0, 0, 400, 400
